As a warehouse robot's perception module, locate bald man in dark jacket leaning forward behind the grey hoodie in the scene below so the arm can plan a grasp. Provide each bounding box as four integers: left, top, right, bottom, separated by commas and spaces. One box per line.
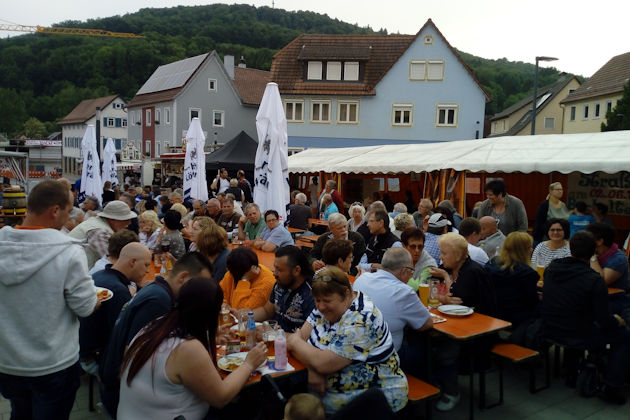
79, 242, 152, 375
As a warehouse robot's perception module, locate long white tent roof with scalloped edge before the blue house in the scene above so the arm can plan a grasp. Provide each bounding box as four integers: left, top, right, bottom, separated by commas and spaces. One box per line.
289, 131, 630, 173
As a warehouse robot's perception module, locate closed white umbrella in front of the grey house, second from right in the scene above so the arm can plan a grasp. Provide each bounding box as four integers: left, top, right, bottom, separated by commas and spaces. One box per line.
184, 117, 208, 201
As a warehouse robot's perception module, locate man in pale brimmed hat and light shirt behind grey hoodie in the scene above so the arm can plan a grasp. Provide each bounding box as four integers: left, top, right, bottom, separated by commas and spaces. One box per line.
70, 200, 137, 268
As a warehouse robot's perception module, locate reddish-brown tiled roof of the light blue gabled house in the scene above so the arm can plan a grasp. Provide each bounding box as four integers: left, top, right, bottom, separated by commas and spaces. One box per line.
271, 19, 490, 99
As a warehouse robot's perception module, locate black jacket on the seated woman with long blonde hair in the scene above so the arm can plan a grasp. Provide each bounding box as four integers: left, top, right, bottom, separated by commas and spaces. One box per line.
485, 258, 538, 327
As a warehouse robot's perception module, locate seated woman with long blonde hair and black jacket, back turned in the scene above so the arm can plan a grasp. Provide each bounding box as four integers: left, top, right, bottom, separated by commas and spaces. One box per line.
486, 232, 538, 338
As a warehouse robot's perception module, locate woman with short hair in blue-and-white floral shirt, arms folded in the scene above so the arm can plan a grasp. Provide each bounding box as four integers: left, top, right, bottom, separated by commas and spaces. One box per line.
287, 267, 408, 414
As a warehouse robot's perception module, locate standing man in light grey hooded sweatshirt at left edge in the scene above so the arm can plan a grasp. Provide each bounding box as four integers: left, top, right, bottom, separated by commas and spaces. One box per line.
0, 180, 97, 420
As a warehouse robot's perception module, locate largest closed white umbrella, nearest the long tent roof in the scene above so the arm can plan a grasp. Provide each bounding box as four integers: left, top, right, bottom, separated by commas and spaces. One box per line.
254, 82, 290, 225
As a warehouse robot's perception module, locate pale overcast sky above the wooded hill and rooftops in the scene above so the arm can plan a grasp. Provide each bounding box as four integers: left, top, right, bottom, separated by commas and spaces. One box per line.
0, 0, 630, 77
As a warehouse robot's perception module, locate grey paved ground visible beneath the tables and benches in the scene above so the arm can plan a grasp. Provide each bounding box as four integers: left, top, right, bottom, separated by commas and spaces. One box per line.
0, 366, 630, 420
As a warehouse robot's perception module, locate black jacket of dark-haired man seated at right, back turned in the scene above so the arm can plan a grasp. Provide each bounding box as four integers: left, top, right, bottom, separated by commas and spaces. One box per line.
541, 257, 618, 342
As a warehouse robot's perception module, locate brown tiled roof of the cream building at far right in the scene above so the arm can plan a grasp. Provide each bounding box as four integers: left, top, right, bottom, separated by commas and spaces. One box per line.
560, 52, 630, 104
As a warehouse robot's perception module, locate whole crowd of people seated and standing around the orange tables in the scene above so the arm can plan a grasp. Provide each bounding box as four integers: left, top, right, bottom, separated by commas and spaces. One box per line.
0, 170, 630, 419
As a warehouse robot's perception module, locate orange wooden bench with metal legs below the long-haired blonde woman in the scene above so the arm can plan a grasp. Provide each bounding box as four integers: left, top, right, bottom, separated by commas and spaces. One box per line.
480, 342, 550, 408
